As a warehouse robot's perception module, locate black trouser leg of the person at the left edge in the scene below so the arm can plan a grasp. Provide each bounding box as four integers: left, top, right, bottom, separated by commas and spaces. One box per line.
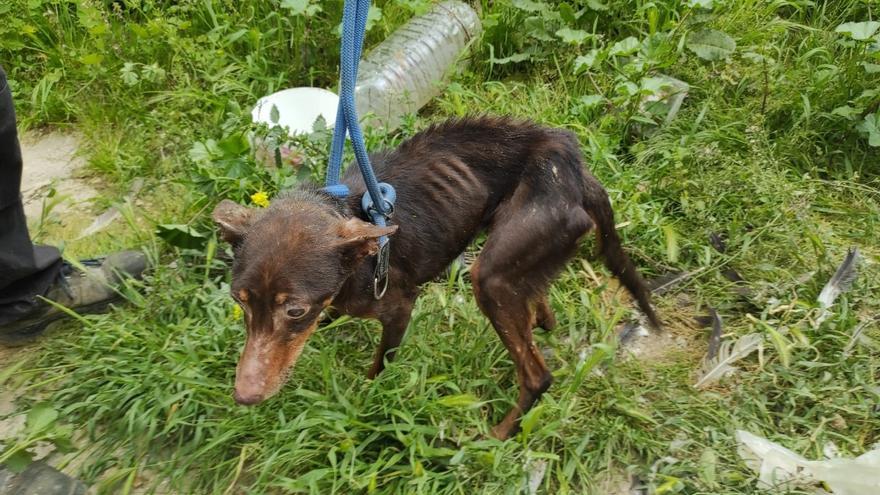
0, 67, 61, 325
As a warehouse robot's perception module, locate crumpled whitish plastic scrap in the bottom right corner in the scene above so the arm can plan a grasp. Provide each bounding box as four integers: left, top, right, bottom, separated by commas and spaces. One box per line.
736, 430, 880, 495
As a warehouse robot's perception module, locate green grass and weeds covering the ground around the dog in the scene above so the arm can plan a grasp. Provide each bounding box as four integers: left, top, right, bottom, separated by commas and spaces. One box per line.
0, 0, 880, 494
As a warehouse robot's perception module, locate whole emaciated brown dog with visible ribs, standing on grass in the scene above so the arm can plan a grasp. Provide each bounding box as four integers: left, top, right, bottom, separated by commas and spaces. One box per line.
213, 117, 659, 438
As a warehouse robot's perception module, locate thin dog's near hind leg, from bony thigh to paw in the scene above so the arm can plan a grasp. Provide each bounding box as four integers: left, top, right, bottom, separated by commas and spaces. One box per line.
471, 192, 592, 439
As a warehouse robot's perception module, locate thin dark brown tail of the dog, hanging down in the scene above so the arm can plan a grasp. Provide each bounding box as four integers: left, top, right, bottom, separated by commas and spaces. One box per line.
584, 174, 661, 330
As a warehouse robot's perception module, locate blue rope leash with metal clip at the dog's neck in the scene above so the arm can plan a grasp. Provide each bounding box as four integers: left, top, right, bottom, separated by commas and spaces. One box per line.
323, 0, 397, 299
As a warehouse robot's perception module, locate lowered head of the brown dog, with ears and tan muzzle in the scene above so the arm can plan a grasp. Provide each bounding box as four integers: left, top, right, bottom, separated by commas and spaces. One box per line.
213, 198, 397, 405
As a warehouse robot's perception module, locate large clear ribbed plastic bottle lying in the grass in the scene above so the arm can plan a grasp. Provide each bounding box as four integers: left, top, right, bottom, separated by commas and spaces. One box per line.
355, 1, 482, 129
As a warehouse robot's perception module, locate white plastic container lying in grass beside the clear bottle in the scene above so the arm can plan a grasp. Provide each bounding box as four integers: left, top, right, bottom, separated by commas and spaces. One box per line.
251, 87, 339, 136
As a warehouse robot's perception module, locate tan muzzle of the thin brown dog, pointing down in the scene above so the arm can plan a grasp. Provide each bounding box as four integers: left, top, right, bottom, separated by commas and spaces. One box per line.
232, 321, 318, 406
